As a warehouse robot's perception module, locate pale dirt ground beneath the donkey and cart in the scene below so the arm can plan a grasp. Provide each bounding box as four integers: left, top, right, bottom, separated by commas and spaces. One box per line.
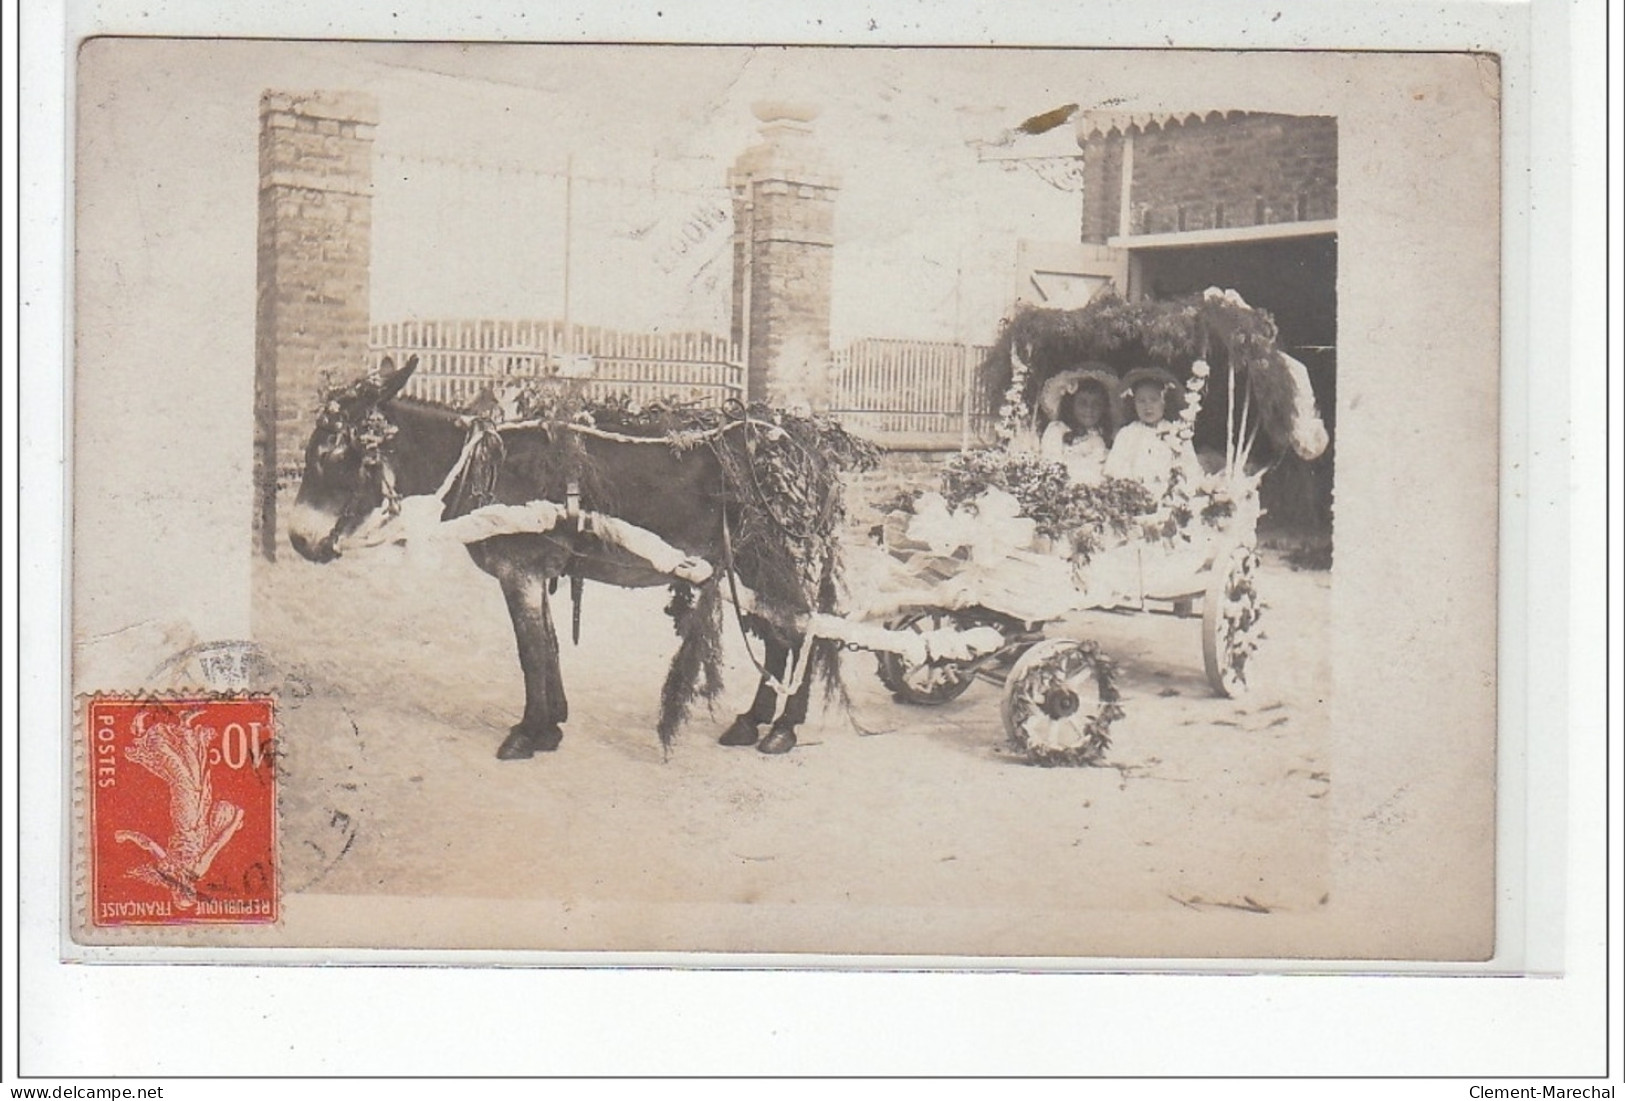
255, 535, 1331, 955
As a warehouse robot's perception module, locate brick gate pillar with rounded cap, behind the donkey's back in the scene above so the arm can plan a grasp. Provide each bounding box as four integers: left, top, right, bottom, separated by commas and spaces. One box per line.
728, 104, 840, 411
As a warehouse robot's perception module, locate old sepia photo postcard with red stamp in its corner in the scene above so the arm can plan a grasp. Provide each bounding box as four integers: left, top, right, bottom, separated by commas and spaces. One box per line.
73, 37, 1505, 968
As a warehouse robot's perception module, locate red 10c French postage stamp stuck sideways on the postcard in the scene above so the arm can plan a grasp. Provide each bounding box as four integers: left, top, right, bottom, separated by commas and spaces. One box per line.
86, 695, 280, 927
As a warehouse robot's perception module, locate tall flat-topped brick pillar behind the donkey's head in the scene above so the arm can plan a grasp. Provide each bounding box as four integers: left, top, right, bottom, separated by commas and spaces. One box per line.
254, 91, 379, 560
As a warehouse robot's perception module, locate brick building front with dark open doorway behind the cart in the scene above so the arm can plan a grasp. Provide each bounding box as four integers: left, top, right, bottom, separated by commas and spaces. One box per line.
1066, 112, 1337, 528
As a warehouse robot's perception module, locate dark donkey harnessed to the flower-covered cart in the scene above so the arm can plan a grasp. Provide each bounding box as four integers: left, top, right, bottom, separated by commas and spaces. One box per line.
289, 356, 864, 760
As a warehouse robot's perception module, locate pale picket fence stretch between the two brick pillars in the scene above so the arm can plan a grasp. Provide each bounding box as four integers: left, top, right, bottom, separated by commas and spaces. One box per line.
372, 320, 744, 406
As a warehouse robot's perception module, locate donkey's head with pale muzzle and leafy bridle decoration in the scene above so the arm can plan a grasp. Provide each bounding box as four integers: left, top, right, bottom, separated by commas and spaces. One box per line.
288, 356, 418, 562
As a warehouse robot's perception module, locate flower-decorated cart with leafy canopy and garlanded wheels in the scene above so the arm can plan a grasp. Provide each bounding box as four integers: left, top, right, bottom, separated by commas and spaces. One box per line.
868, 289, 1326, 765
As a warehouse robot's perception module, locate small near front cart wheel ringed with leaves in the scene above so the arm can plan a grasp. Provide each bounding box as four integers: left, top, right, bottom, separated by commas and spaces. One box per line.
1003, 638, 1123, 765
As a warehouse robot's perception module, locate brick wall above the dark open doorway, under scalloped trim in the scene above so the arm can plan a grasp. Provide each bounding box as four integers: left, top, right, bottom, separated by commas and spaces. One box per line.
1084, 114, 1337, 240
